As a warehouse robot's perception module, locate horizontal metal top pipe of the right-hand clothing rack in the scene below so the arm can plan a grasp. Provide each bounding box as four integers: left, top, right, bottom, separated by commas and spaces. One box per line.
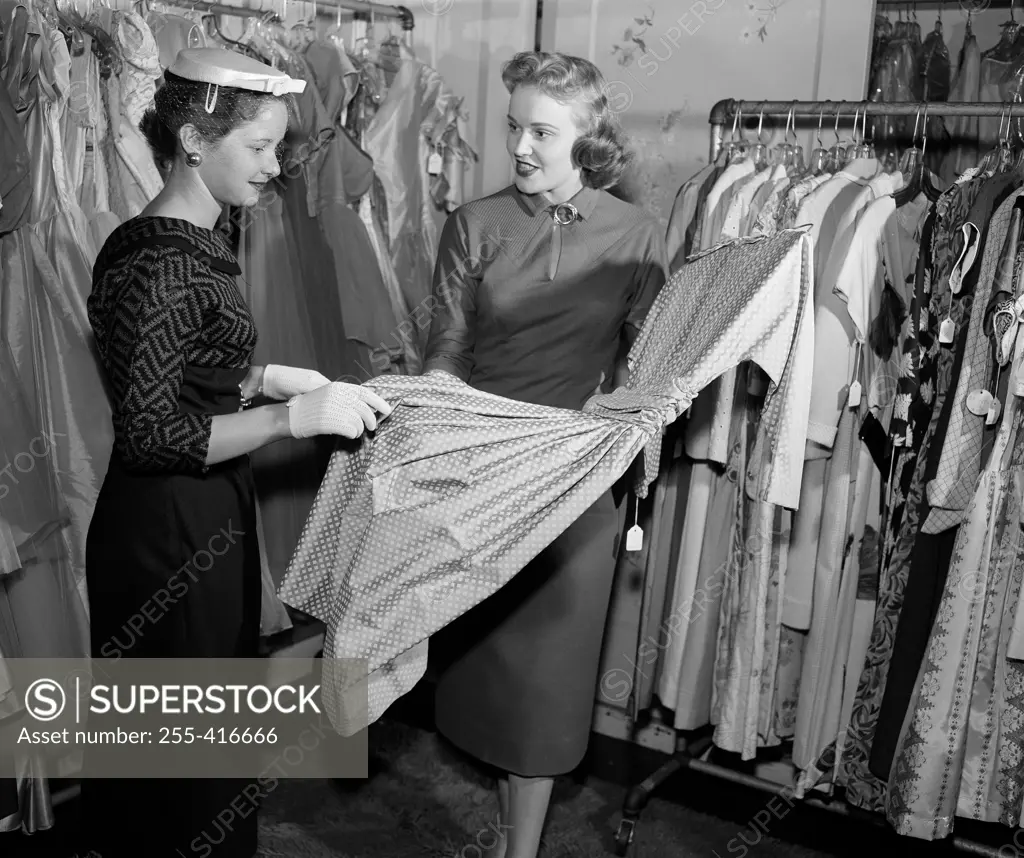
708, 98, 1024, 161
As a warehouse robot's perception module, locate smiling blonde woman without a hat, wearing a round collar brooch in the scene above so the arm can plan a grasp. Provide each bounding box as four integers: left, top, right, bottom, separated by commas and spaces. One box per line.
426, 52, 667, 858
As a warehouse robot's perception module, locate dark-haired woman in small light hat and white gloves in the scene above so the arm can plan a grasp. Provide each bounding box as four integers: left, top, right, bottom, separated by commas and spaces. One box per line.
83, 48, 390, 858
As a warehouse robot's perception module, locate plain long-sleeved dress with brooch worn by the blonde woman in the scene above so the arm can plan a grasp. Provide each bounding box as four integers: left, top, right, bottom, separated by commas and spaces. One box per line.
426, 187, 667, 777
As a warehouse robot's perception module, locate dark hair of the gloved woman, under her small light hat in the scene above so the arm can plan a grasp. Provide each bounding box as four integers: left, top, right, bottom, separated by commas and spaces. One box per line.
139, 72, 292, 176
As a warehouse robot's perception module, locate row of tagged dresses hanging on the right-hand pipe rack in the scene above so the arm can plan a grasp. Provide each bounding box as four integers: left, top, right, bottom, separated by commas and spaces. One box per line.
622, 100, 1024, 840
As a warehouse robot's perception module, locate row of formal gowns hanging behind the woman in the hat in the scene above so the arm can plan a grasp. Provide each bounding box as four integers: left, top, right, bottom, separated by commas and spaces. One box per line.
0, 0, 475, 830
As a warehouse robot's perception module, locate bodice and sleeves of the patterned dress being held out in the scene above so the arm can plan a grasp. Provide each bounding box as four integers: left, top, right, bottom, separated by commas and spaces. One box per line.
588, 230, 814, 509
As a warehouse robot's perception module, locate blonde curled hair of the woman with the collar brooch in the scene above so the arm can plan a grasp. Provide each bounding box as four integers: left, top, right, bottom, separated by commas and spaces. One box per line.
502, 51, 633, 190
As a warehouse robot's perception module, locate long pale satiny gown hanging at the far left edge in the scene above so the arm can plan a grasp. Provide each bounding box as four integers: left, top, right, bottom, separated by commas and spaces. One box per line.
0, 3, 113, 655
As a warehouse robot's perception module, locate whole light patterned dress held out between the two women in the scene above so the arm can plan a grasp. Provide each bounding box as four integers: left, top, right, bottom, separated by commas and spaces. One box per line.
281, 231, 810, 735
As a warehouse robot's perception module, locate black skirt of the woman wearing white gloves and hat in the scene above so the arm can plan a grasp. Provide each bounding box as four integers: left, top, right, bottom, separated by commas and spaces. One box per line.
82, 457, 261, 858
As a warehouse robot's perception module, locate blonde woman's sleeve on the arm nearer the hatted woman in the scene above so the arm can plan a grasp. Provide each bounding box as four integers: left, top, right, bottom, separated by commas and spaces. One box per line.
424, 209, 481, 382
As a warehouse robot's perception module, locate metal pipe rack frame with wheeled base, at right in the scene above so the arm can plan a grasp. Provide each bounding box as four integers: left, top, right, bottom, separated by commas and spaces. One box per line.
615, 94, 1024, 858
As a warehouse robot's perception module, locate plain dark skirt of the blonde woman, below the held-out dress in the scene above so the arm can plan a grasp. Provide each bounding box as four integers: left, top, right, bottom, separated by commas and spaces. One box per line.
431, 491, 618, 777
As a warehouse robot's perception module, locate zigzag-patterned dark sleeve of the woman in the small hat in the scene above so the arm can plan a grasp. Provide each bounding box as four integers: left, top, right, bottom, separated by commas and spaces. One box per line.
106, 252, 213, 481
